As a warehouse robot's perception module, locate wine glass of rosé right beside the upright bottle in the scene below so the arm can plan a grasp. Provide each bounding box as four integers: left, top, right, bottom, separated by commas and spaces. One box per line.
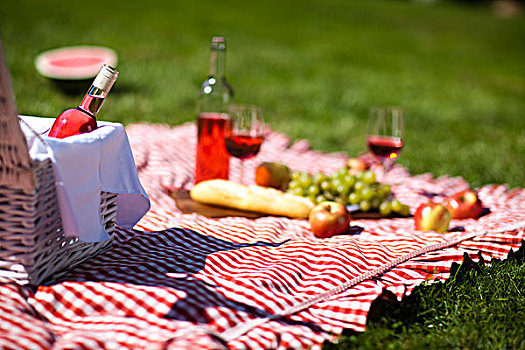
224, 105, 264, 183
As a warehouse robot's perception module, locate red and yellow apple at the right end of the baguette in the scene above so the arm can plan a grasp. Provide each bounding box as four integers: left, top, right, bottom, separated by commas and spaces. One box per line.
308, 201, 350, 238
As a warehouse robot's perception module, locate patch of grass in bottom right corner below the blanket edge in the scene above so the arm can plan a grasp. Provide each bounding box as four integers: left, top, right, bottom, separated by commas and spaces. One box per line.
325, 246, 525, 350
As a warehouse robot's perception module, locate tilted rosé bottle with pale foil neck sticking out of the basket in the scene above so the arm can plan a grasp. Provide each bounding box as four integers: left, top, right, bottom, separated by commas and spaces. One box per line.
48, 64, 118, 139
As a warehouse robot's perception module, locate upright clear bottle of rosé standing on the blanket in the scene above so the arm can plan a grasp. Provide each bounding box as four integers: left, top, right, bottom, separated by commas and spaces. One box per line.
195, 37, 233, 183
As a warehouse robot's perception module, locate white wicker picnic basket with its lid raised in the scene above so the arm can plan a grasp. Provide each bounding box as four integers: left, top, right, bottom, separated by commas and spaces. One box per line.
0, 43, 117, 285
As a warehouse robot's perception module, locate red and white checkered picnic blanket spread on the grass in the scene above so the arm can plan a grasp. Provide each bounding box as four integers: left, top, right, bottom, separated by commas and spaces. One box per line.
0, 123, 525, 349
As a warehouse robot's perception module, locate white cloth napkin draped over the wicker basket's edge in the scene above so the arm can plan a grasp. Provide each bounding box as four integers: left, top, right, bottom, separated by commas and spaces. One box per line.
20, 116, 150, 242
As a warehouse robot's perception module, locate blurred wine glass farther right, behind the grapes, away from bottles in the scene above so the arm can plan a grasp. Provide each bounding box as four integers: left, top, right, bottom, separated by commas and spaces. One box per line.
366, 106, 405, 171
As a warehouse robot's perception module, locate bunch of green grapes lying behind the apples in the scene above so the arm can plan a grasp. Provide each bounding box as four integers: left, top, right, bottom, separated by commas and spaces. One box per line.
287, 167, 410, 216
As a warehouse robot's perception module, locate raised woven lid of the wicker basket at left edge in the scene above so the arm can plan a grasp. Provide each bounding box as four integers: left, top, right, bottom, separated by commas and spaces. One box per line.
0, 42, 35, 191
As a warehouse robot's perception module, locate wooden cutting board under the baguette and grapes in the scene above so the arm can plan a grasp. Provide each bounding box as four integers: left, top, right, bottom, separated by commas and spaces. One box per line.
170, 190, 406, 220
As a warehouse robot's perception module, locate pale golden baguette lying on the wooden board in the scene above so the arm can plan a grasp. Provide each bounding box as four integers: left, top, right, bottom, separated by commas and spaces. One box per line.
190, 180, 313, 218
